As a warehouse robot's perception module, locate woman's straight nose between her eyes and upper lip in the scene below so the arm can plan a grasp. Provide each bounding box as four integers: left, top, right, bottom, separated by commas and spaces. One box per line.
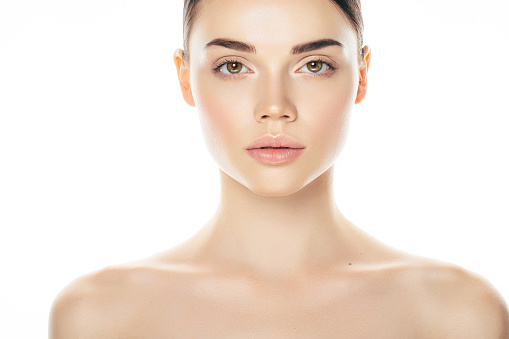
255, 76, 297, 122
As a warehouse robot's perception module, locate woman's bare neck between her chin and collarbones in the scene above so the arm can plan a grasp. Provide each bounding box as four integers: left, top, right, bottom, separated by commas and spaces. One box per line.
194, 167, 347, 275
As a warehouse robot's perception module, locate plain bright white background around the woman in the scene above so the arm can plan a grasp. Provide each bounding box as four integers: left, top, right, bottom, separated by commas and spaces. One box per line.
0, 0, 509, 338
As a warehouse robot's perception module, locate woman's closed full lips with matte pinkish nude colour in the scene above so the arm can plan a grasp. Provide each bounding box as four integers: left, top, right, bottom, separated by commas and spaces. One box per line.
246, 134, 305, 165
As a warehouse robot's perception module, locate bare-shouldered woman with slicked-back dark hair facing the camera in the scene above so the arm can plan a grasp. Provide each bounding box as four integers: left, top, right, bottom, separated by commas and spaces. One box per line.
50, 0, 509, 338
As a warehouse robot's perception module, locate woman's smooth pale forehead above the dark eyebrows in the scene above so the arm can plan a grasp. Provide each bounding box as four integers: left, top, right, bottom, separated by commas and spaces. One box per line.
190, 0, 357, 51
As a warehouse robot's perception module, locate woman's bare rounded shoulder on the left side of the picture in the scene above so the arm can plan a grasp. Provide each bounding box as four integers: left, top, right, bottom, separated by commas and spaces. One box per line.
49, 266, 172, 339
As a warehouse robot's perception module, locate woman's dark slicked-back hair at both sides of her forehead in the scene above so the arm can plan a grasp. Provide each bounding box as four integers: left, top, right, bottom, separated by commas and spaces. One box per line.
184, 0, 364, 60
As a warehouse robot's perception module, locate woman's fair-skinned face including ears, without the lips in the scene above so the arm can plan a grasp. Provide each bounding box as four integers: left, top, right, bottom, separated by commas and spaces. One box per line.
175, 0, 366, 196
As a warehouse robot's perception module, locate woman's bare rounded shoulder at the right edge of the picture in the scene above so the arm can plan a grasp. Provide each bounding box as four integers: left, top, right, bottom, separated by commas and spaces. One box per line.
398, 259, 509, 339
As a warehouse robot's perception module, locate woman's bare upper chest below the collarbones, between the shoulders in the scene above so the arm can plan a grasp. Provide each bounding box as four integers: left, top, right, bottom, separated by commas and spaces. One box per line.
121, 286, 419, 338
